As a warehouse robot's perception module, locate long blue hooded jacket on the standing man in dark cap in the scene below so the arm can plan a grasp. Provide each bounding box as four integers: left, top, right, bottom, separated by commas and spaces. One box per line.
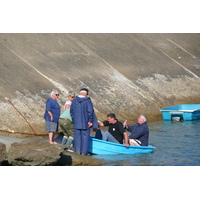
70, 96, 97, 129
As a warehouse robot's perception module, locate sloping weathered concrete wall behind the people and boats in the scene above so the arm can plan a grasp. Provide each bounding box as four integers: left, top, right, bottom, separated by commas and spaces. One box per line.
0, 34, 200, 133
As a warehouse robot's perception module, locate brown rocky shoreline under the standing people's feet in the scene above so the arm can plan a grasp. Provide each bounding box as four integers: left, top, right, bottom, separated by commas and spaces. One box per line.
0, 135, 106, 166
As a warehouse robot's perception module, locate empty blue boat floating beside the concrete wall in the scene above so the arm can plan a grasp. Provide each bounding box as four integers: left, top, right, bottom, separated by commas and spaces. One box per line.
160, 104, 200, 121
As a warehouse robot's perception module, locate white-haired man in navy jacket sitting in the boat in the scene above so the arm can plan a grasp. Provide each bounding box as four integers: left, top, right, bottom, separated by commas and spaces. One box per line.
123, 115, 149, 146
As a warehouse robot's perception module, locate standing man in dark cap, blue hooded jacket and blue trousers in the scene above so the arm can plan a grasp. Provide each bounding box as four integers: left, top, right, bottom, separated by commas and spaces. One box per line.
70, 88, 97, 155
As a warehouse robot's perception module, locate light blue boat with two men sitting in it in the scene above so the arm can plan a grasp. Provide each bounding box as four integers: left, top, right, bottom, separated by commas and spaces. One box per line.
88, 137, 156, 155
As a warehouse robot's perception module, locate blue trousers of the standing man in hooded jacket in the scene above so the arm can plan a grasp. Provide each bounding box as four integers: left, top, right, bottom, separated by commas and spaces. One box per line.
74, 129, 90, 155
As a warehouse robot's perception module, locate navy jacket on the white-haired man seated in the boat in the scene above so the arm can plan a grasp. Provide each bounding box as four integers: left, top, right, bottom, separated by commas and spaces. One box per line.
127, 122, 149, 146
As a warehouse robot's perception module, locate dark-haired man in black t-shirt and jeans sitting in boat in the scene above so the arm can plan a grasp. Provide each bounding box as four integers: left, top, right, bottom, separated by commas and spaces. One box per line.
99, 113, 129, 147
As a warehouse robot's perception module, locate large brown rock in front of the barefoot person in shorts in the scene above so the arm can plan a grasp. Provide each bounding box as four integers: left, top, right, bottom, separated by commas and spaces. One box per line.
8, 138, 66, 166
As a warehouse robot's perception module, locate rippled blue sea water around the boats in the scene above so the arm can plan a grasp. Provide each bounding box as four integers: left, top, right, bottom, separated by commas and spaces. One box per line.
92, 120, 200, 166
